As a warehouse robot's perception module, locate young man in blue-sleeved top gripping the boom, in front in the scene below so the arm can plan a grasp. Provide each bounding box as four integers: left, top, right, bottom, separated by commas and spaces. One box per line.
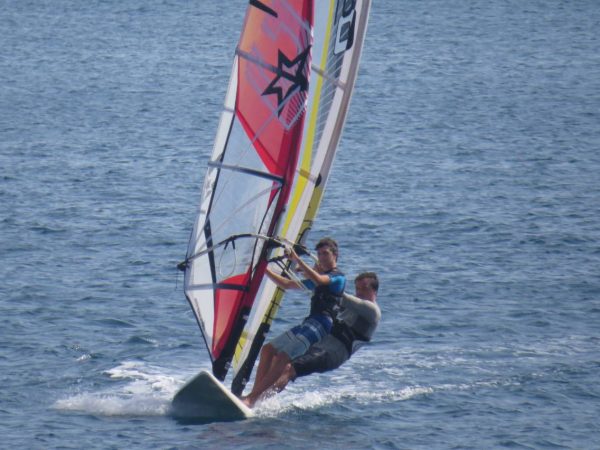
243, 238, 346, 407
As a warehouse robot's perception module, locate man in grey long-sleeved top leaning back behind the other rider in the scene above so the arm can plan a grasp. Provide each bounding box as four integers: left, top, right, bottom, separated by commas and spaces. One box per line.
264, 272, 381, 402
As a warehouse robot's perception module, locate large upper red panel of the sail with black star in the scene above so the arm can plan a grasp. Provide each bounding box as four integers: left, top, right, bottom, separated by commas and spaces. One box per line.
236, 0, 313, 178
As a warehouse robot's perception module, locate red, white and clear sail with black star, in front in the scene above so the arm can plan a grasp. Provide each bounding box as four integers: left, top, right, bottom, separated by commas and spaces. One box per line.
181, 0, 313, 380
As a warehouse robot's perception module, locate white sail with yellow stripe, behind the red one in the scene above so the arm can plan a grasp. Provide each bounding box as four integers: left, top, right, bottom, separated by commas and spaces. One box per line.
231, 0, 371, 395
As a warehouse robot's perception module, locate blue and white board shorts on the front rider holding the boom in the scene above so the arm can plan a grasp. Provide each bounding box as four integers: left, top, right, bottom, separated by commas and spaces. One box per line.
270, 315, 332, 359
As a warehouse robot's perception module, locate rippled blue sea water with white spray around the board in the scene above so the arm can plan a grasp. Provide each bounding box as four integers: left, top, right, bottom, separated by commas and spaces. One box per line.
0, 0, 600, 449
